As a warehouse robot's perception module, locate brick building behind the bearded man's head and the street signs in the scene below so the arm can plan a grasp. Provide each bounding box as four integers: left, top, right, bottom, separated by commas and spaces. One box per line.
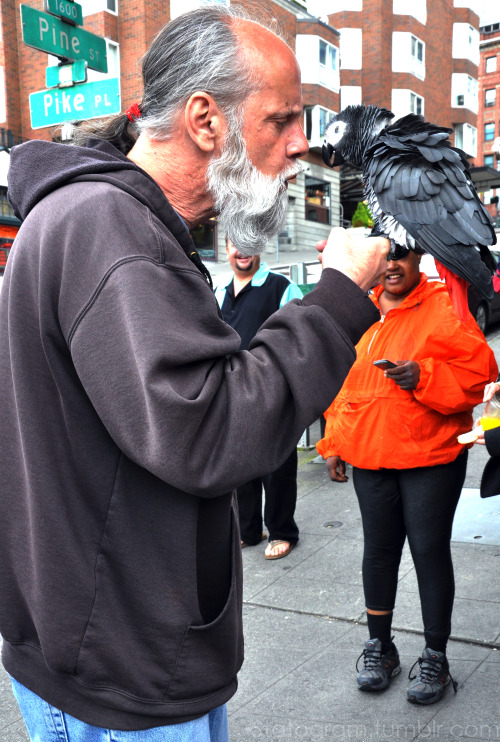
0, 0, 340, 266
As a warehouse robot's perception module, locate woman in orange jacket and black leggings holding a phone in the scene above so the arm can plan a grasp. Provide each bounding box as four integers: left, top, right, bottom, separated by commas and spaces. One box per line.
317, 248, 497, 704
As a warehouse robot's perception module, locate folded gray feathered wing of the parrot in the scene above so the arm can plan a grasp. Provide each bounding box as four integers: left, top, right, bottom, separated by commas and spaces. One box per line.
364, 115, 496, 299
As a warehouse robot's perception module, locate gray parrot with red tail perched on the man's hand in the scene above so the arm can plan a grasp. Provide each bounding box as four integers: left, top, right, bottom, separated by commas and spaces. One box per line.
322, 105, 496, 318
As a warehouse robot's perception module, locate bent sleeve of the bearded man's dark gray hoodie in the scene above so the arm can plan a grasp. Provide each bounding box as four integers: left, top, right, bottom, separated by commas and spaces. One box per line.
69, 260, 375, 496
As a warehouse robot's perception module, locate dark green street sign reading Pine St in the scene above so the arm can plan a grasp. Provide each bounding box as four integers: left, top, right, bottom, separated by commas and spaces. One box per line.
21, 5, 108, 72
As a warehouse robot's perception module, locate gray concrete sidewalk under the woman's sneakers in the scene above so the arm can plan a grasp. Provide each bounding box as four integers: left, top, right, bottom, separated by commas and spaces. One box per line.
0, 342, 500, 742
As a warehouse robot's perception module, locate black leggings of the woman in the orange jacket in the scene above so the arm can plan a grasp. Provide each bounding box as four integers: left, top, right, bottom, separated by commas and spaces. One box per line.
353, 452, 467, 646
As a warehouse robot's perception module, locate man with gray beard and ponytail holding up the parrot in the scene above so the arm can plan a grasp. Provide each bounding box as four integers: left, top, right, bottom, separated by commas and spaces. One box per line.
0, 5, 389, 742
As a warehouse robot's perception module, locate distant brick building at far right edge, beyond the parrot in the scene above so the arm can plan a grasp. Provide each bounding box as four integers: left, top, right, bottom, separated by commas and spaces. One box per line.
475, 21, 500, 227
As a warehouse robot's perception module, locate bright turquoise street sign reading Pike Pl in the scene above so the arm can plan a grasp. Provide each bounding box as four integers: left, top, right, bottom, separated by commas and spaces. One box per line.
30, 77, 120, 129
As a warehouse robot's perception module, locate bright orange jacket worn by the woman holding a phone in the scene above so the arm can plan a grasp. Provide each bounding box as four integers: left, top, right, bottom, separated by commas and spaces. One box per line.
316, 273, 498, 469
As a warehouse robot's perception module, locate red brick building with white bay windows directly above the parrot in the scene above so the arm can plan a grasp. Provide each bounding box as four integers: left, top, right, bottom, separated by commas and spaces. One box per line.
309, 0, 479, 222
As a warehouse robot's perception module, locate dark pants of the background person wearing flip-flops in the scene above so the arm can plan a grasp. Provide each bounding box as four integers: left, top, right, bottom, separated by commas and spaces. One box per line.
237, 448, 299, 546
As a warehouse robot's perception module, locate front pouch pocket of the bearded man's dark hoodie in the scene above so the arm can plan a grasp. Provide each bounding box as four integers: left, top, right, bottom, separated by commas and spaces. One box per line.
165, 512, 243, 700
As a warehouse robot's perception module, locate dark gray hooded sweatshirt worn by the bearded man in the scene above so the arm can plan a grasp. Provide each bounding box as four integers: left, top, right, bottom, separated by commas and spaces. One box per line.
0, 141, 378, 730
